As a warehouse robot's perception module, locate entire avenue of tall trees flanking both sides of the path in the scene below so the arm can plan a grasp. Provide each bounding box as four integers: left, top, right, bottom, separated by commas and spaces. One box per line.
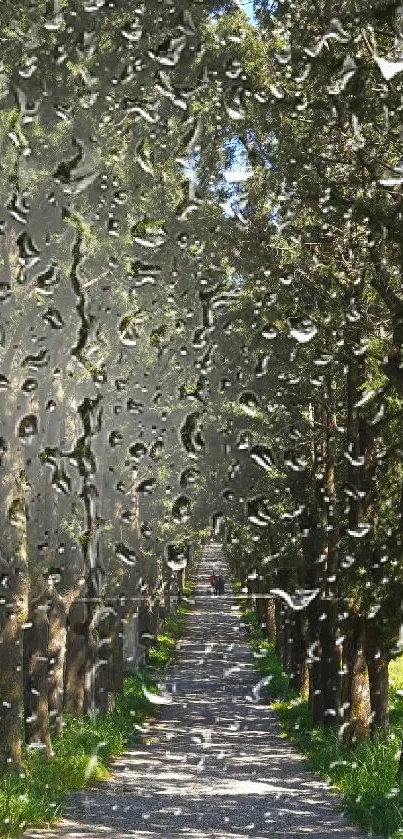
0, 0, 403, 780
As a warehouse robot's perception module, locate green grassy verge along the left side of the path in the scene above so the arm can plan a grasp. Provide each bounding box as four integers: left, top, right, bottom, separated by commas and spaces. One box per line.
0, 583, 192, 837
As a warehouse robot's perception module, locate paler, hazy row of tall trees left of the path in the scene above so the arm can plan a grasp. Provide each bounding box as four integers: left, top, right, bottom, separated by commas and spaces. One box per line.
0, 0, 243, 767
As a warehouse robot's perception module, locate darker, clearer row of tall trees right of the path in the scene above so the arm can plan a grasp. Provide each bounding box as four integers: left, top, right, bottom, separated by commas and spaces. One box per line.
196, 0, 403, 741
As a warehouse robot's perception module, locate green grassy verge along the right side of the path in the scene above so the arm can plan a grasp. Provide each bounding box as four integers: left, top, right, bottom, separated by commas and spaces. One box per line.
238, 592, 403, 839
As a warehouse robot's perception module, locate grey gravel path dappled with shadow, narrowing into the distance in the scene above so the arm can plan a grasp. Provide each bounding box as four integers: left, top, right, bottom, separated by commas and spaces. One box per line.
24, 546, 367, 839
